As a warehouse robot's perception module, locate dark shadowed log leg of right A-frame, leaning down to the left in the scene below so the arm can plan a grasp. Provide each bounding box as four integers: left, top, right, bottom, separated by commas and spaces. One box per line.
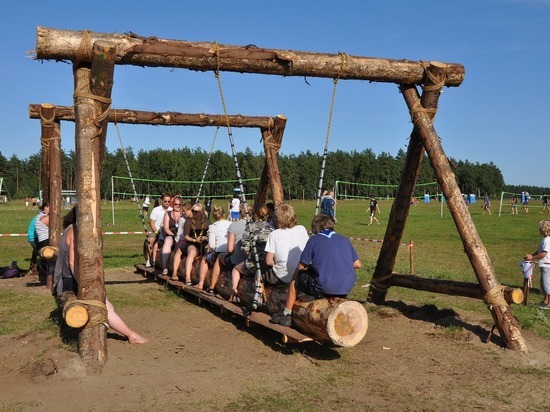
367, 62, 446, 304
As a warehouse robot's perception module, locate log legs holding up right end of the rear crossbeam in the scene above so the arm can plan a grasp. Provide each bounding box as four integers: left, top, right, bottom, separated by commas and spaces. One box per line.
256, 114, 287, 205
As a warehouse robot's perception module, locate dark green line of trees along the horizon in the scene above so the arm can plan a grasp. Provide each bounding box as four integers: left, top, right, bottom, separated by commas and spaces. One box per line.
0, 147, 550, 199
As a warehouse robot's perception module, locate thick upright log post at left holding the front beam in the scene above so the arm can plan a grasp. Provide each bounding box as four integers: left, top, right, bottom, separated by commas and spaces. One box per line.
74, 35, 116, 372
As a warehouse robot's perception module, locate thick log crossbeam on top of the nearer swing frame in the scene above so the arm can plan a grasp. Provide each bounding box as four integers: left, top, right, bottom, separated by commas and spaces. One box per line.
36, 26, 465, 87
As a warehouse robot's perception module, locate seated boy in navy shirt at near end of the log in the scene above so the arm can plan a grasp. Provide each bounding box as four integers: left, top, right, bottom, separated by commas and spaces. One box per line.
270, 214, 361, 326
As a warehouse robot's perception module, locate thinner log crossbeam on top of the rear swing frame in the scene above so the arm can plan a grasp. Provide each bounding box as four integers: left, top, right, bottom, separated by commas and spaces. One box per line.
29, 104, 286, 129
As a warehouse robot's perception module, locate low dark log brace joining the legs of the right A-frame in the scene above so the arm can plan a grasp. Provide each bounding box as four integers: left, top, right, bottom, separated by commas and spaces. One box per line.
390, 273, 523, 304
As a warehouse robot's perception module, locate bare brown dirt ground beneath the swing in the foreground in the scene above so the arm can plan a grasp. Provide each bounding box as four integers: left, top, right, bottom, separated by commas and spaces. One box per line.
0, 271, 550, 411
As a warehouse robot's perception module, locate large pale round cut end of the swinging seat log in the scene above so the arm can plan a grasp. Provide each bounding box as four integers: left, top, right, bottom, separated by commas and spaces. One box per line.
327, 300, 369, 348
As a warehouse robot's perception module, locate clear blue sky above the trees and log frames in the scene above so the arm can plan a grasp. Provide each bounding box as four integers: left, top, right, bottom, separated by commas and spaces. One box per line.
0, 0, 550, 186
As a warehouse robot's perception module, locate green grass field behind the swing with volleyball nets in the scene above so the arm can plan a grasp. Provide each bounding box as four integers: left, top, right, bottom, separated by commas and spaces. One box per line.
0, 200, 550, 338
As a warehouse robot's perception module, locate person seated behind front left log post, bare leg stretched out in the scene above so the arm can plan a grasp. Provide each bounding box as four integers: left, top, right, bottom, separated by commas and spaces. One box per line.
54, 206, 149, 344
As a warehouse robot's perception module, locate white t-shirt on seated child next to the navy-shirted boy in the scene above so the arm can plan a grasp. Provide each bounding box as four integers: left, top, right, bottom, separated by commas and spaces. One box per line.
265, 225, 309, 283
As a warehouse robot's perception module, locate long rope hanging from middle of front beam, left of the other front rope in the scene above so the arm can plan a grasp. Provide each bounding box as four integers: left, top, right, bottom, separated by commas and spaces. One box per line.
214, 42, 263, 310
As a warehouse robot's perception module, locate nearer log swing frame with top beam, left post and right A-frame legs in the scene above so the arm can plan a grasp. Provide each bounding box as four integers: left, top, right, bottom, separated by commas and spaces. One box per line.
36, 27, 527, 365
